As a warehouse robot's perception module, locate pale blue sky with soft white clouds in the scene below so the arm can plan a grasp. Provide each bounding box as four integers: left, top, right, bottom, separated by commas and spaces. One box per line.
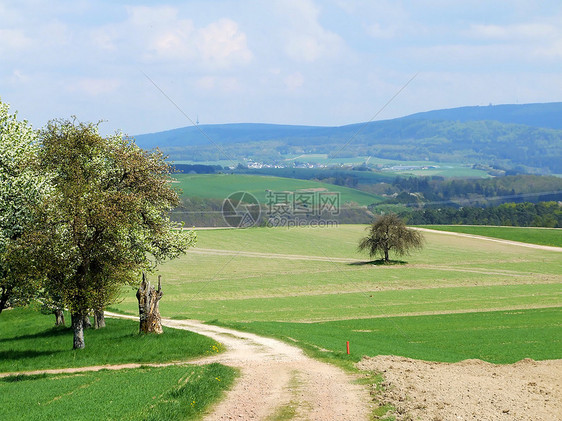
0, 0, 562, 135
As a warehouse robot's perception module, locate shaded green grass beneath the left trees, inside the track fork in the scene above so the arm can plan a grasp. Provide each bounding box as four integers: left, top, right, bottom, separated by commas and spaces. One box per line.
0, 308, 222, 370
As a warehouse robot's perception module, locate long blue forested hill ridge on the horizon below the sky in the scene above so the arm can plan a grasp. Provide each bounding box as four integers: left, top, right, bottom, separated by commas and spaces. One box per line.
135, 103, 562, 174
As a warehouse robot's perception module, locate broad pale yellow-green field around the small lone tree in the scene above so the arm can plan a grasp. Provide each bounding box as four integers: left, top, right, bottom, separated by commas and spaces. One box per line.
111, 225, 562, 321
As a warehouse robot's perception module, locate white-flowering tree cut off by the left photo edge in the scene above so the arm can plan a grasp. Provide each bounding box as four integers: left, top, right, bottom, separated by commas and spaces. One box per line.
0, 101, 49, 313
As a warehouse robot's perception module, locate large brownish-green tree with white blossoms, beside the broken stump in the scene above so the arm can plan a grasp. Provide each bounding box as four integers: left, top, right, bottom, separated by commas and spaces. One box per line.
39, 120, 195, 349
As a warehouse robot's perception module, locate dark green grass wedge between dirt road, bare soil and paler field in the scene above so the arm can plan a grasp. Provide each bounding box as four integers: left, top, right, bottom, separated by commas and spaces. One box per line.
218, 307, 562, 364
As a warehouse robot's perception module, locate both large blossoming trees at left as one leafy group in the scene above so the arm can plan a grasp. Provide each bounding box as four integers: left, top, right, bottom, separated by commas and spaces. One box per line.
0, 102, 195, 348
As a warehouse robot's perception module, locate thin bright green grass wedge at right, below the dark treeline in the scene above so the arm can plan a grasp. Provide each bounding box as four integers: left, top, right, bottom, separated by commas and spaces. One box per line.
423, 225, 562, 247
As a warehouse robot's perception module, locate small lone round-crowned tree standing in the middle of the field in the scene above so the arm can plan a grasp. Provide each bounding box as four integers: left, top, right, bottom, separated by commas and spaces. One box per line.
359, 213, 424, 262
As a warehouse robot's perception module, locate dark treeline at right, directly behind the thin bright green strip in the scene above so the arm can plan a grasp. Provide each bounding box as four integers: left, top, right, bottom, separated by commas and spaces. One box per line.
405, 202, 562, 228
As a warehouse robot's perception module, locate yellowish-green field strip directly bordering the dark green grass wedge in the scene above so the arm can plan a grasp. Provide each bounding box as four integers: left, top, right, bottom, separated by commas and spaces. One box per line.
141, 283, 562, 322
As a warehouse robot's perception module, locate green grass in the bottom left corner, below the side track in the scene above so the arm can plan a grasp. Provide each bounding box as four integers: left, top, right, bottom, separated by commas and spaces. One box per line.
0, 364, 236, 420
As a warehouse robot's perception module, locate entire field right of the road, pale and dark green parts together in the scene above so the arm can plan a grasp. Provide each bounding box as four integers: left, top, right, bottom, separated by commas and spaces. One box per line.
110, 225, 562, 362
